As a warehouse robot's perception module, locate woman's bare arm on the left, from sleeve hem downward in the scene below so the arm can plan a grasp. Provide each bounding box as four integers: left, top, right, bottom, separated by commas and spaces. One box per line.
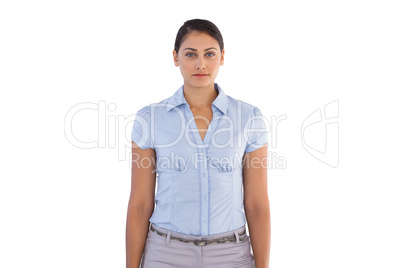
126, 141, 156, 268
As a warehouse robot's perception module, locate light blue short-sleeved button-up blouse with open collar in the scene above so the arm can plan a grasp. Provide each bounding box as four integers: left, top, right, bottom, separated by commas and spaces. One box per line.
131, 83, 268, 236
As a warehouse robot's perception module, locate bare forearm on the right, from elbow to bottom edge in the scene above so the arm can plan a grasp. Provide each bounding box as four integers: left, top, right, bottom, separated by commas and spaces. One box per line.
245, 205, 271, 268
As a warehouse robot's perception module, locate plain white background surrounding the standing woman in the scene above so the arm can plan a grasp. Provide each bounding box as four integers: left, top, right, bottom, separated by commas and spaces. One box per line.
0, 0, 402, 268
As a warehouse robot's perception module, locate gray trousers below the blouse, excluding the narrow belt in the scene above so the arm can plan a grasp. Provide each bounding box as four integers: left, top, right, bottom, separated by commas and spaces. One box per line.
140, 225, 255, 268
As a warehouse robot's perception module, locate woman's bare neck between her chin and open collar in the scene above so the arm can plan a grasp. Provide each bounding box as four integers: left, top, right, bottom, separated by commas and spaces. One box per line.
183, 83, 219, 109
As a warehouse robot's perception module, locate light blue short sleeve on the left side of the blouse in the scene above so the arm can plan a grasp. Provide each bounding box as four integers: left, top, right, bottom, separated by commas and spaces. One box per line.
131, 105, 154, 149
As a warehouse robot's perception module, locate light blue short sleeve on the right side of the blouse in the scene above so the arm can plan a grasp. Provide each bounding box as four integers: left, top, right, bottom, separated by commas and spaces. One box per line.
245, 106, 268, 153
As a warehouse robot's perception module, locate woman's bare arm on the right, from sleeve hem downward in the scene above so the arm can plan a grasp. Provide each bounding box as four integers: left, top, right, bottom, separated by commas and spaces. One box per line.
243, 144, 271, 268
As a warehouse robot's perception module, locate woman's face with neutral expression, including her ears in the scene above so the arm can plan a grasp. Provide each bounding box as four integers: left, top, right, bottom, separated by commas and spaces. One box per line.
173, 32, 225, 87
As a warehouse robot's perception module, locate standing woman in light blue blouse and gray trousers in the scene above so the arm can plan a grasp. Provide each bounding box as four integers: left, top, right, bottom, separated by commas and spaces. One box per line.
126, 19, 271, 268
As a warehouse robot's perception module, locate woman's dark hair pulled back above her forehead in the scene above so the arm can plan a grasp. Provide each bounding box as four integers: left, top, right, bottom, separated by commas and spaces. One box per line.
174, 19, 223, 53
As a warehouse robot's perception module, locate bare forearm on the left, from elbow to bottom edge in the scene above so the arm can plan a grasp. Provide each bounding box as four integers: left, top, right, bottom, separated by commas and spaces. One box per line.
126, 205, 153, 268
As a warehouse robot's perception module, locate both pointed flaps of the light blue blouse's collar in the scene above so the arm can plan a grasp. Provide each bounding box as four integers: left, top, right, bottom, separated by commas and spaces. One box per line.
167, 83, 228, 114
